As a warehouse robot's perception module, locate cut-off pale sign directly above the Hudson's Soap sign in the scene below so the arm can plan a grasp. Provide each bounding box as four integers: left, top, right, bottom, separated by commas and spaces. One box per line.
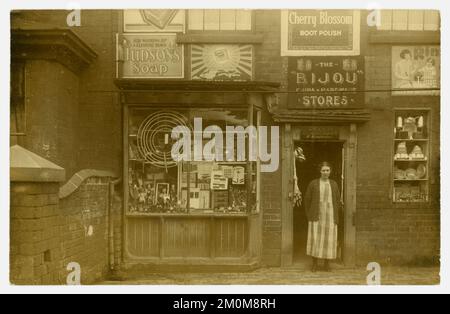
123, 9, 185, 33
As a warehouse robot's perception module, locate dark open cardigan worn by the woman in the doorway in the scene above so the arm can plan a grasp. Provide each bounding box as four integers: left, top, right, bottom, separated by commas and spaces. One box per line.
305, 179, 342, 225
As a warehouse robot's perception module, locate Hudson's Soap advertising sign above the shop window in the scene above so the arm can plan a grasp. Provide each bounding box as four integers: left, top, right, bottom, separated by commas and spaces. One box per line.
117, 34, 184, 79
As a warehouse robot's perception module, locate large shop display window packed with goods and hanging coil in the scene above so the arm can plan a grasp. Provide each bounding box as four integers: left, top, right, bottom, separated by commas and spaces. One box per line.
127, 108, 260, 215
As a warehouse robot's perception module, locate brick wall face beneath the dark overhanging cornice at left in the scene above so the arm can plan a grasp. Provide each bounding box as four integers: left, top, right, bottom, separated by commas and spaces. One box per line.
18, 60, 79, 176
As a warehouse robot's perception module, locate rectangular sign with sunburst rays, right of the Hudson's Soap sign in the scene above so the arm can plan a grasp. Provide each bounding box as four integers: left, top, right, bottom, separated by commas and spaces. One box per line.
191, 45, 253, 81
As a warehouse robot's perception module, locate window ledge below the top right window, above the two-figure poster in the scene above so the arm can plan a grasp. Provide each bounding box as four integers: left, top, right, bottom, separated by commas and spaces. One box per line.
369, 30, 441, 44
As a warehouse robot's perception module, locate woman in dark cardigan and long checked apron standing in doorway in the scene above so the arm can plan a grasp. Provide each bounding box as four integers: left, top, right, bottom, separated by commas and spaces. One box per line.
305, 162, 341, 272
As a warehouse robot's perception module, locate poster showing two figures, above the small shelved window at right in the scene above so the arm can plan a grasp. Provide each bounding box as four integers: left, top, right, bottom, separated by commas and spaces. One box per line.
392, 45, 441, 96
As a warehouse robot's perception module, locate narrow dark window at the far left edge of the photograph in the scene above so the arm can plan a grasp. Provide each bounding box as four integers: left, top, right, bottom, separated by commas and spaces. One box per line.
10, 62, 26, 136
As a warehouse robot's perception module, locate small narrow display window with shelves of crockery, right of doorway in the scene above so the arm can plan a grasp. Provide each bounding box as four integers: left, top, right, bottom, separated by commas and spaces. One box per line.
393, 109, 431, 203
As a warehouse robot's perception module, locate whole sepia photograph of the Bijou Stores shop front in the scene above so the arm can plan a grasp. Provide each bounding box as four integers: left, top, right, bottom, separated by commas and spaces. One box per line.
4, 1, 442, 294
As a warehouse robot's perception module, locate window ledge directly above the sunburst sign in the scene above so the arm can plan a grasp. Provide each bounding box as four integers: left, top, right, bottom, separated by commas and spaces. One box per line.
177, 32, 264, 44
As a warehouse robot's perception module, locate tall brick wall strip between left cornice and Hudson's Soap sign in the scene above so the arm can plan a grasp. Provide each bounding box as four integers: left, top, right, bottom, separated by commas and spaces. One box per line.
74, 10, 123, 173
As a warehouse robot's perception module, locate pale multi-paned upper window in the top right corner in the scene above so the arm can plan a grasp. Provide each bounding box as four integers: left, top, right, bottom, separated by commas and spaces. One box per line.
378, 10, 440, 31
